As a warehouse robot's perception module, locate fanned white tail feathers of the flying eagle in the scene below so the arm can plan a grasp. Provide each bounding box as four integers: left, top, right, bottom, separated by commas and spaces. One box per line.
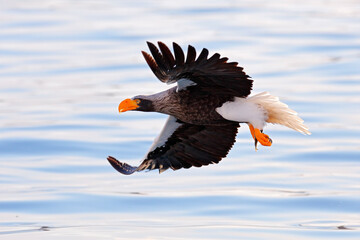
246, 92, 311, 135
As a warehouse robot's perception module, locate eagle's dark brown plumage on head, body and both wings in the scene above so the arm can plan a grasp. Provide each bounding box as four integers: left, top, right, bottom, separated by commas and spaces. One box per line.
108, 42, 252, 174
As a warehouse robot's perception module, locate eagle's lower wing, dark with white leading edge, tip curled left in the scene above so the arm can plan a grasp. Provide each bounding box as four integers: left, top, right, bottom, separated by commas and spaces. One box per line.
108, 116, 239, 175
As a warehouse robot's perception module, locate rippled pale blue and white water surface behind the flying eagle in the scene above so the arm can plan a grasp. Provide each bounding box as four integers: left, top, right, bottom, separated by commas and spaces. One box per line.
0, 0, 360, 239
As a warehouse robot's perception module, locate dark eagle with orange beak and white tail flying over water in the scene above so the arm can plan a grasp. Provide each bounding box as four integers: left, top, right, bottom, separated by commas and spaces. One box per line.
108, 42, 310, 175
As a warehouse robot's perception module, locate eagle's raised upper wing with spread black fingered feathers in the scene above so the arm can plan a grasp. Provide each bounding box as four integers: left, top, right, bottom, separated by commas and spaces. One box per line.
142, 42, 253, 97
